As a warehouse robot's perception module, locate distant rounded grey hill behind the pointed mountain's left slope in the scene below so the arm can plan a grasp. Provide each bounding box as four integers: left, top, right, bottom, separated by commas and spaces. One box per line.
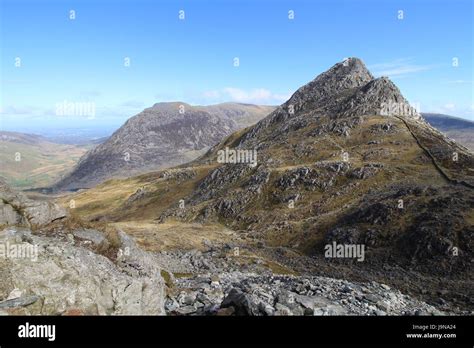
54, 102, 273, 190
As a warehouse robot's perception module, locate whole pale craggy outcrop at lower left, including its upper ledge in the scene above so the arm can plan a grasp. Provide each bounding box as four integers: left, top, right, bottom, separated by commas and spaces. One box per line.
0, 182, 164, 315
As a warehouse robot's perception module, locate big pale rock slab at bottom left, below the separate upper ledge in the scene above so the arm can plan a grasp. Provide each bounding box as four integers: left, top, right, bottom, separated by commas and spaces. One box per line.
0, 227, 164, 315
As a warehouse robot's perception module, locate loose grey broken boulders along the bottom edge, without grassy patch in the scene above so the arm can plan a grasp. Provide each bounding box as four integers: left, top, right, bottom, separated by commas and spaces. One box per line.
165, 272, 444, 316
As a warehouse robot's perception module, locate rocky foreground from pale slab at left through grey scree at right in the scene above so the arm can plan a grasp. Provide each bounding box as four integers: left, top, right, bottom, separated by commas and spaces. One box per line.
0, 219, 458, 316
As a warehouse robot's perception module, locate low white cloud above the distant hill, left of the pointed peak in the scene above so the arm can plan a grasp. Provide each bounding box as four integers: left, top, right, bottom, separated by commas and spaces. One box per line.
203, 87, 290, 104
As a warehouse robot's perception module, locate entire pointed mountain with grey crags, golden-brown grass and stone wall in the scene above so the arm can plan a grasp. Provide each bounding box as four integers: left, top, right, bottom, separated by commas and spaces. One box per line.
63, 58, 474, 310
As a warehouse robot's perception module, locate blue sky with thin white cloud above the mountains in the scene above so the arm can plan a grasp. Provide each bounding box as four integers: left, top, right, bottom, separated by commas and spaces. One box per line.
0, 0, 474, 130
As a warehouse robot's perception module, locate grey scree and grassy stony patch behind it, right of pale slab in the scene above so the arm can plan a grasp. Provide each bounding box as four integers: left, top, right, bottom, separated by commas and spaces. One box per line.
156, 245, 449, 316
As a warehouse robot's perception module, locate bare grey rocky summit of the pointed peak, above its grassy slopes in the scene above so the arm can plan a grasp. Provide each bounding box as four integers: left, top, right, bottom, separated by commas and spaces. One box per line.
243, 58, 423, 145
